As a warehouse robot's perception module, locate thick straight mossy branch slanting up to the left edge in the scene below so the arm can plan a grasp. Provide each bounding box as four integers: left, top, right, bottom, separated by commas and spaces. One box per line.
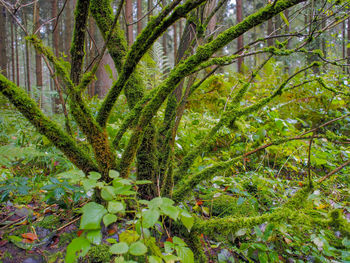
0, 74, 98, 173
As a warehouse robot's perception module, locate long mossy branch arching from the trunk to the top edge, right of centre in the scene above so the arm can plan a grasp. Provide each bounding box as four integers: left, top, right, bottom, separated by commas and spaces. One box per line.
117, 0, 304, 178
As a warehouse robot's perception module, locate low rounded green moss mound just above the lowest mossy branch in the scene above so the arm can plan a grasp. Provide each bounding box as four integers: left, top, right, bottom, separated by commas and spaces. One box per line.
204, 195, 258, 217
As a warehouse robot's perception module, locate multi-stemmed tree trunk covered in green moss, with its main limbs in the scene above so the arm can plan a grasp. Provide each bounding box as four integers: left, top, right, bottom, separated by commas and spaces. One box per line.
0, 0, 314, 198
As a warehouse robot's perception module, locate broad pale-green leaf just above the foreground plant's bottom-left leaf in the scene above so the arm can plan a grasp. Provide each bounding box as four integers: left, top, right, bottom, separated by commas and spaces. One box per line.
80, 202, 107, 230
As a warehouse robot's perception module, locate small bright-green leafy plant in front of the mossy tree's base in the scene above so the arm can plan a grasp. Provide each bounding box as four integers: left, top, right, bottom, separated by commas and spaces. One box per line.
66, 170, 194, 263
